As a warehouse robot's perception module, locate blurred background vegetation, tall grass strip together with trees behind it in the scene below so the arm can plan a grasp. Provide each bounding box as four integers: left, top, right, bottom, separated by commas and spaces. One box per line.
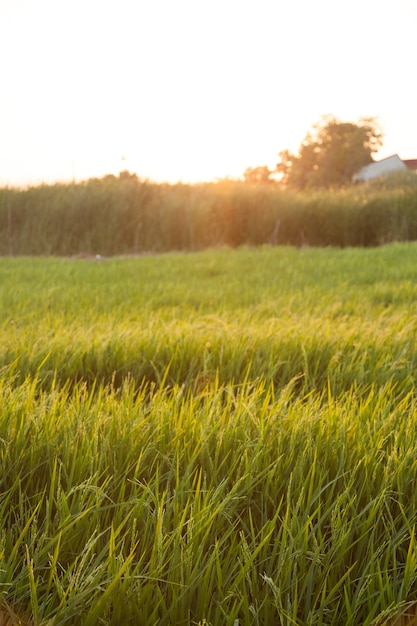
0, 116, 417, 256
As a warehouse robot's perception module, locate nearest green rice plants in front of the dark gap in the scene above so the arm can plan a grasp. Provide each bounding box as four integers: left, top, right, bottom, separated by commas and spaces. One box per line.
0, 381, 417, 624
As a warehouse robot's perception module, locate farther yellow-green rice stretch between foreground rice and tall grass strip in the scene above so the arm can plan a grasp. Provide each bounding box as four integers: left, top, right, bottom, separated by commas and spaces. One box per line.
0, 244, 417, 395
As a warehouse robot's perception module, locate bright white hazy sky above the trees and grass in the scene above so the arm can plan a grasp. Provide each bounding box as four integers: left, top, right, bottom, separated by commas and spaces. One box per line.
0, 0, 417, 185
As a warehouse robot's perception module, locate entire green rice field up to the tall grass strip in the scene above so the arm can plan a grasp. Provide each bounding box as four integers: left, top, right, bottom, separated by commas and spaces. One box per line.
0, 244, 417, 626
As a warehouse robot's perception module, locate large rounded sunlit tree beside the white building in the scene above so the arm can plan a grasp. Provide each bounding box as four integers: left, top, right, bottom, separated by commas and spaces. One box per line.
277, 116, 383, 189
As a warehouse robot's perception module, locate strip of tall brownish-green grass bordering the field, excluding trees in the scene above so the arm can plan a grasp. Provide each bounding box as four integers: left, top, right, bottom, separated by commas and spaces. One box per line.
0, 173, 417, 256
